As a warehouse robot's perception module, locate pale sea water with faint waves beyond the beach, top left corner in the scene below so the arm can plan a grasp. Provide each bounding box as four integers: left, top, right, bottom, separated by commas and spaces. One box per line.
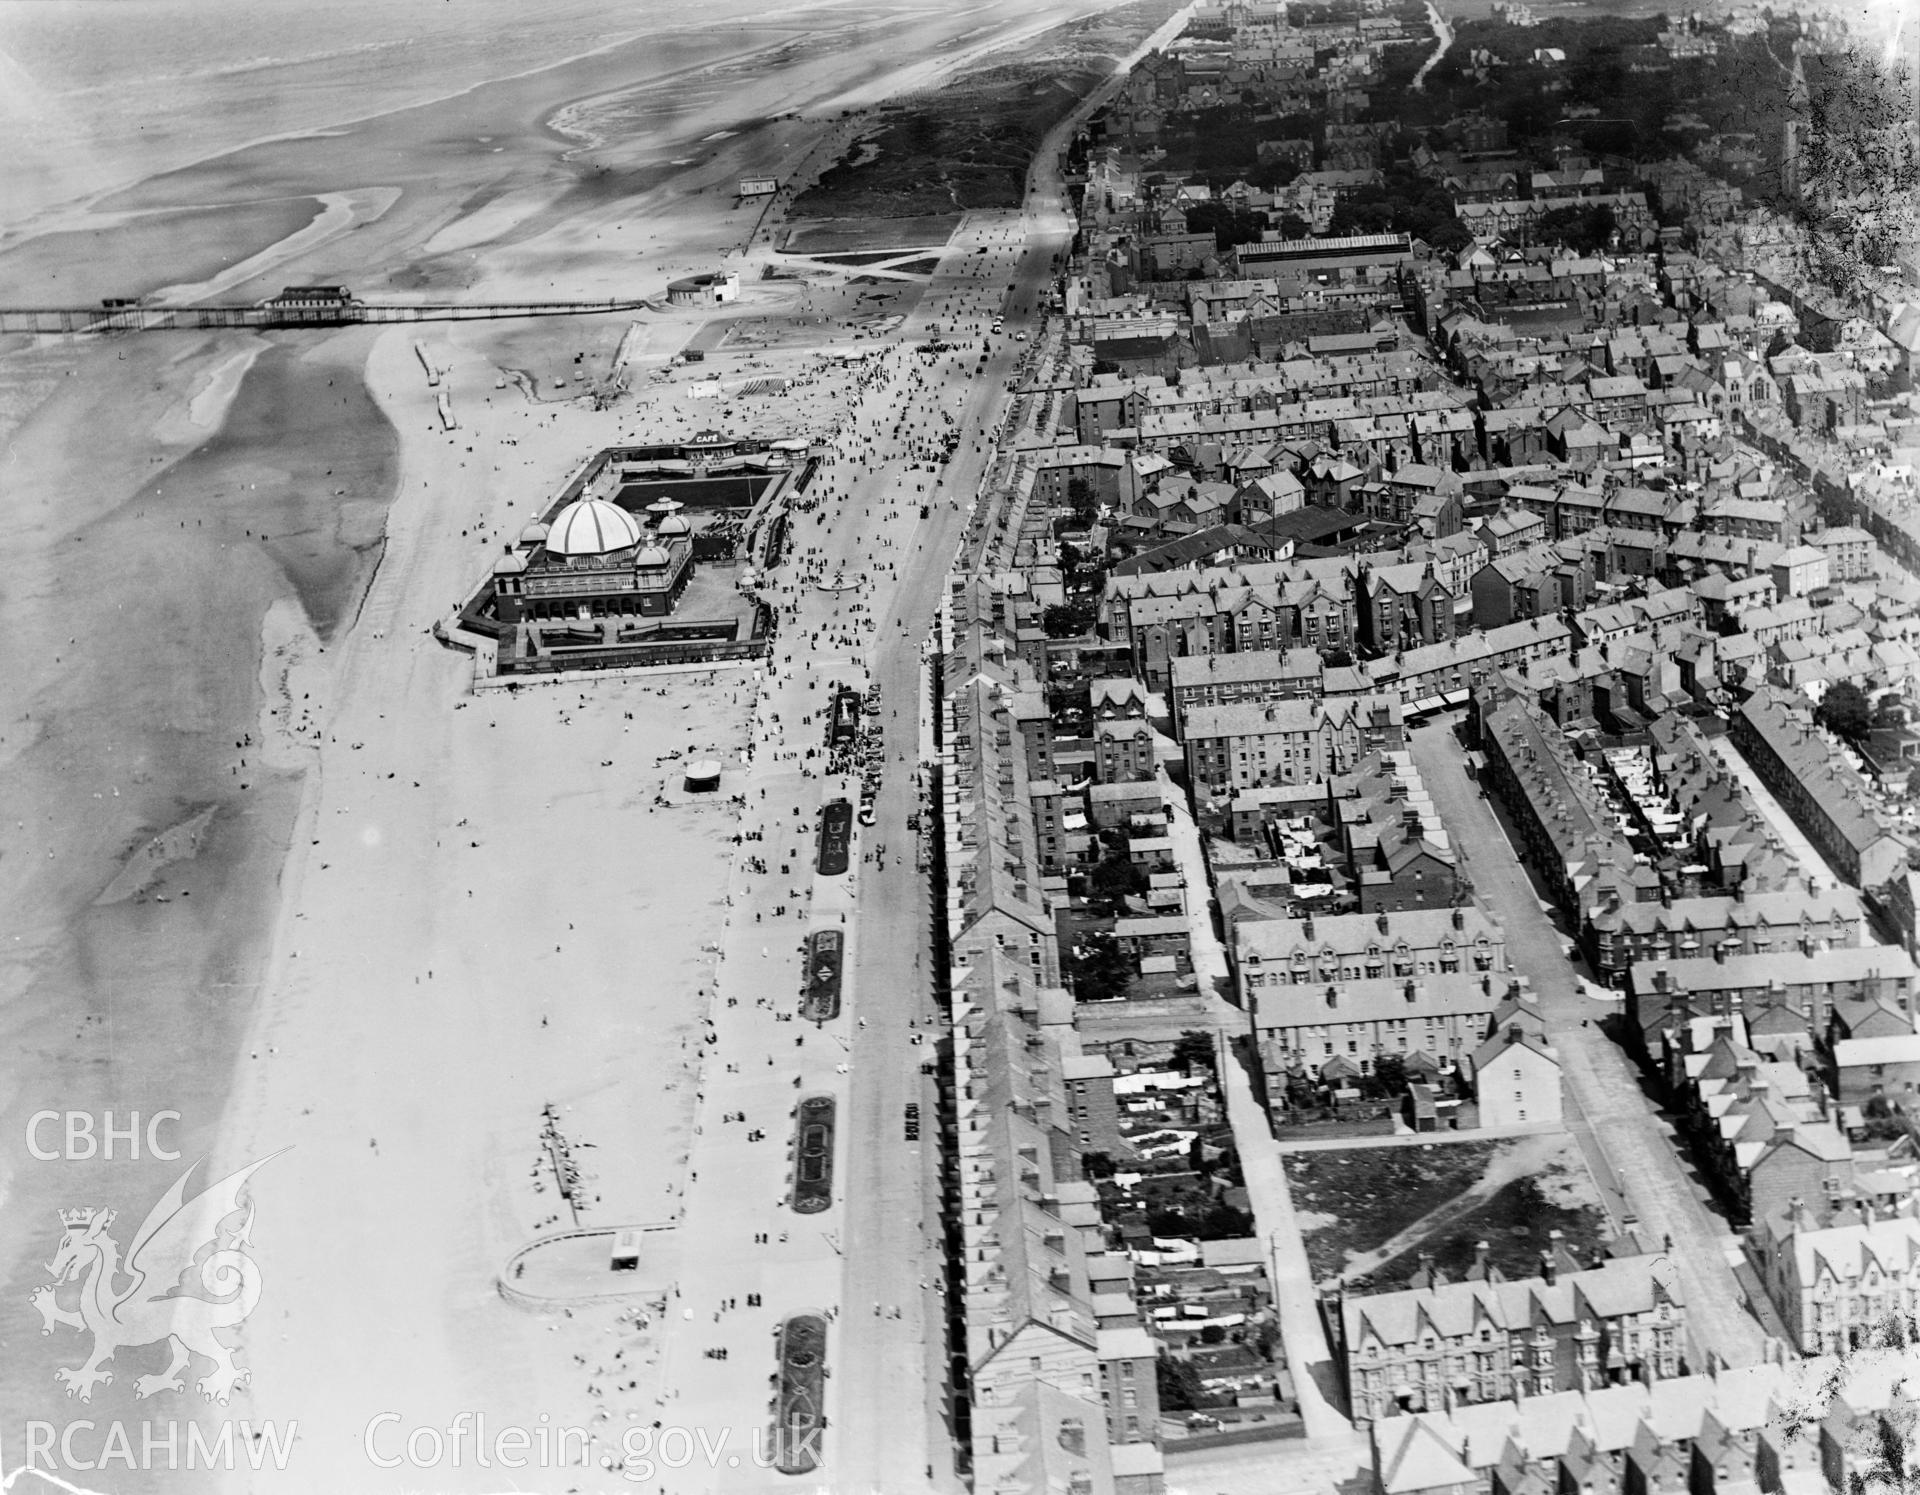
0, 0, 783, 232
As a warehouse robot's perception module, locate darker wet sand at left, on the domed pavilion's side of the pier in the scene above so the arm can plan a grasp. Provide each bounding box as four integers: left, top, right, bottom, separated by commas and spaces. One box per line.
0, 330, 394, 1481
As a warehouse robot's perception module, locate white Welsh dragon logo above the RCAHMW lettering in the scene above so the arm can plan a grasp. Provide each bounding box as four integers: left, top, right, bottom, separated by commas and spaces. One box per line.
29, 1153, 278, 1405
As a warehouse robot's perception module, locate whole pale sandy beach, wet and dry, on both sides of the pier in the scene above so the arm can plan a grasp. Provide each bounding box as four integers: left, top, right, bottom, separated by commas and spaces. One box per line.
0, 4, 1144, 1491
